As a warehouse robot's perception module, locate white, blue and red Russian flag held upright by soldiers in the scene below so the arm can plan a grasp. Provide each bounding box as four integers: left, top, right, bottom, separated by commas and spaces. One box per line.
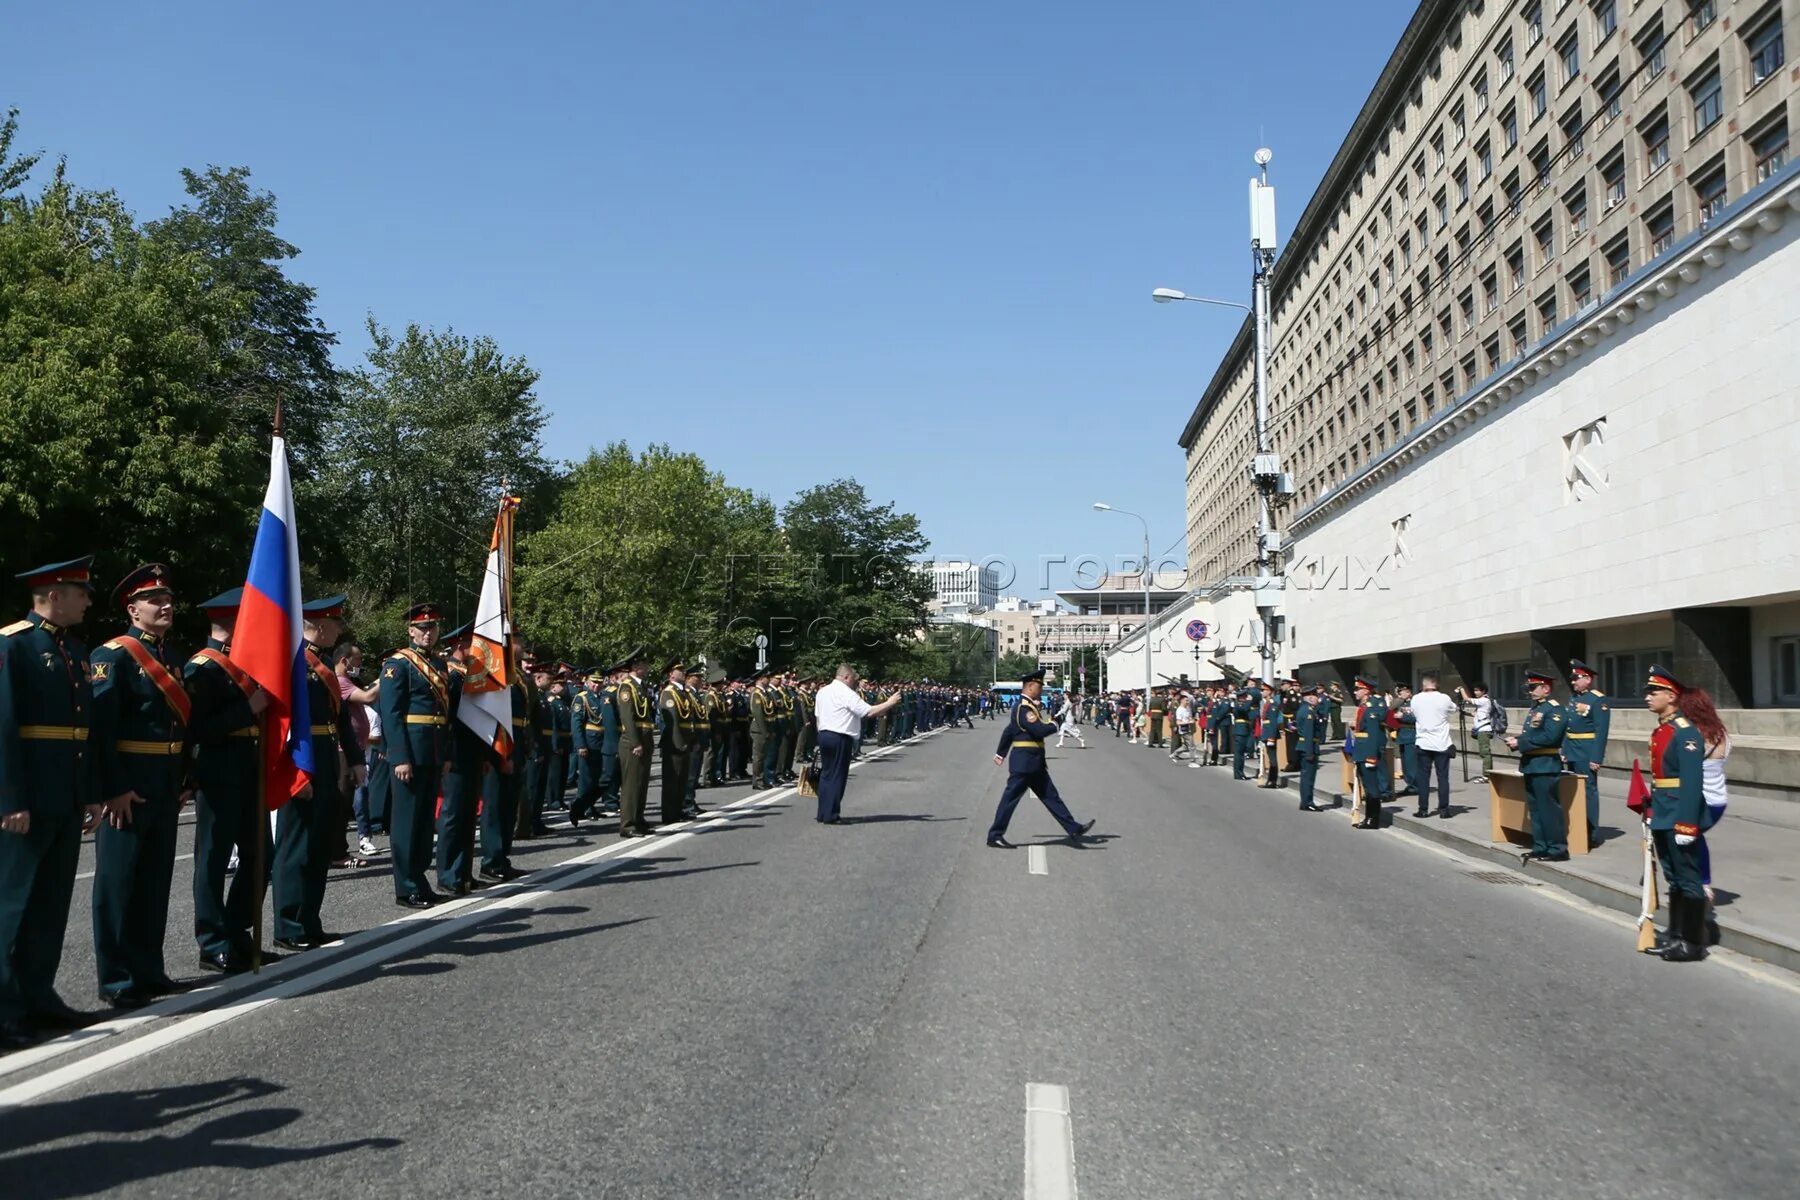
230, 434, 313, 810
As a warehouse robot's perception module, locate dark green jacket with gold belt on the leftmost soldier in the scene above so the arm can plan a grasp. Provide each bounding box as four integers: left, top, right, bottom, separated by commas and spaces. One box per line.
0, 613, 99, 820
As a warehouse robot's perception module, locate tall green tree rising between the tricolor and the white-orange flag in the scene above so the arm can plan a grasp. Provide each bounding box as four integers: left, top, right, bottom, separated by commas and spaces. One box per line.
309, 317, 553, 644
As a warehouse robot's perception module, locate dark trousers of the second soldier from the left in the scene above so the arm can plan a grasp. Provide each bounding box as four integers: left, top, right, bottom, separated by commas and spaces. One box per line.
92, 788, 180, 993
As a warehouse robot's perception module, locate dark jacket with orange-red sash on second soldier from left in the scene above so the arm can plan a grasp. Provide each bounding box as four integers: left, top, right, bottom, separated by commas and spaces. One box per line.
88, 630, 193, 799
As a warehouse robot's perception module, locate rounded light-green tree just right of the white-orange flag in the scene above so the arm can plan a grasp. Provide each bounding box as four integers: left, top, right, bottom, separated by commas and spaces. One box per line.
515, 443, 781, 671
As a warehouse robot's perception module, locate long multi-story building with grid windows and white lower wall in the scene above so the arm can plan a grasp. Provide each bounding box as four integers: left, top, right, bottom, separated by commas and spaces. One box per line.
1181, 0, 1800, 734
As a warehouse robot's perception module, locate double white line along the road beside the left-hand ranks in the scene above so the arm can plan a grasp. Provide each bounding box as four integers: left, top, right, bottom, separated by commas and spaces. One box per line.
0, 730, 938, 1110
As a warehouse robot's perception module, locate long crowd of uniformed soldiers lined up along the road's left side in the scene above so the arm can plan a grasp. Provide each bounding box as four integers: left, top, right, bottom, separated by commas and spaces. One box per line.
0, 558, 999, 1051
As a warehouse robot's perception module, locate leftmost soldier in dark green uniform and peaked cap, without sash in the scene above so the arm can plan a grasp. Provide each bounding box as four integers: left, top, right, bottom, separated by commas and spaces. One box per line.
0, 556, 103, 1051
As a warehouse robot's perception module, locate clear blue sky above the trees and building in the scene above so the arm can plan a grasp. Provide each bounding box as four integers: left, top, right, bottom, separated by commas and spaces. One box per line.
0, 0, 1413, 594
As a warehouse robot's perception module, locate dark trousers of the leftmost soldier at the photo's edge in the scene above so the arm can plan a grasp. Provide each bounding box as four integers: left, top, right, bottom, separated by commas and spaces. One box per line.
0, 811, 81, 1022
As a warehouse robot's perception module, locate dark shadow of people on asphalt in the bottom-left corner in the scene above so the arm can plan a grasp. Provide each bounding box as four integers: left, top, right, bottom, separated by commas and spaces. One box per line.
0, 1078, 400, 1200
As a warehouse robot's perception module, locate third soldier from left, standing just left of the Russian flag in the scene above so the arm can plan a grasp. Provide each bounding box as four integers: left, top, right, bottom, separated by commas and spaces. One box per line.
182, 588, 274, 975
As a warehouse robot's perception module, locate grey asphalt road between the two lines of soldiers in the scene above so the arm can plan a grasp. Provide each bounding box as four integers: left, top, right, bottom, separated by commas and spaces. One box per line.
0, 721, 1800, 1200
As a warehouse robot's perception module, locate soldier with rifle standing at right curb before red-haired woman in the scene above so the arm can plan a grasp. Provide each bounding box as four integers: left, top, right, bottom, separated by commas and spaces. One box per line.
1643, 667, 1708, 963
